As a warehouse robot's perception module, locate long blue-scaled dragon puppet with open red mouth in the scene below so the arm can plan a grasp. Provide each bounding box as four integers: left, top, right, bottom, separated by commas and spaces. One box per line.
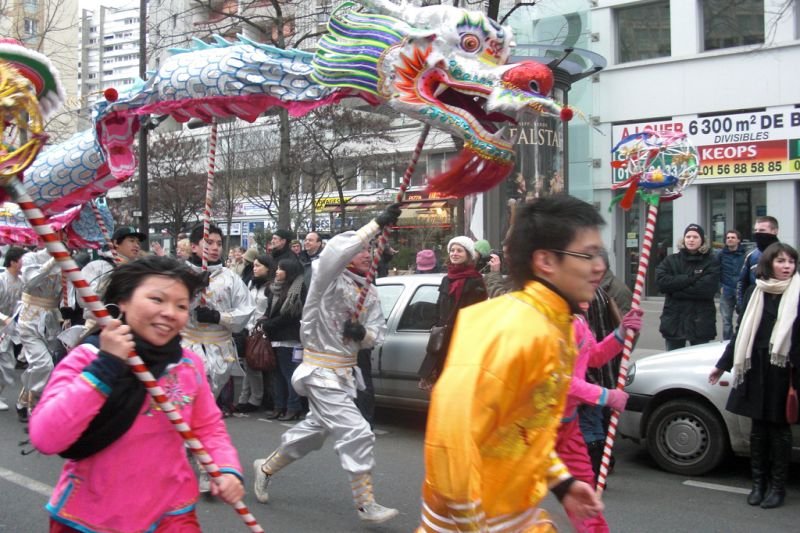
15, 0, 572, 220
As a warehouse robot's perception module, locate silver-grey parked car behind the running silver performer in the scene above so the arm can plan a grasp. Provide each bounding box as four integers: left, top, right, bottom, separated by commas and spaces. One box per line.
372, 274, 444, 410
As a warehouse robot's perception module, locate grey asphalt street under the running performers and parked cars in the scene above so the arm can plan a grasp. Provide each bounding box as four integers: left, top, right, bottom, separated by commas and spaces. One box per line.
0, 300, 800, 533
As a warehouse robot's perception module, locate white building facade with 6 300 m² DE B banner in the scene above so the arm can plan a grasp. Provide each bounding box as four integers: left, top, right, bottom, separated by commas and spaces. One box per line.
590, 0, 800, 295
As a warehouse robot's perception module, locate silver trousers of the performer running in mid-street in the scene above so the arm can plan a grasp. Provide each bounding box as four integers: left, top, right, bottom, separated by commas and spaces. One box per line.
277, 383, 375, 474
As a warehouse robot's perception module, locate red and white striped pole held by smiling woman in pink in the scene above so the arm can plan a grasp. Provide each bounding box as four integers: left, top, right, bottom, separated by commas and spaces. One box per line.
5, 178, 264, 533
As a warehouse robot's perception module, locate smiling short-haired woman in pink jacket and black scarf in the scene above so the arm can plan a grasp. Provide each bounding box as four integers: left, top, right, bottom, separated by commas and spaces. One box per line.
29, 256, 244, 533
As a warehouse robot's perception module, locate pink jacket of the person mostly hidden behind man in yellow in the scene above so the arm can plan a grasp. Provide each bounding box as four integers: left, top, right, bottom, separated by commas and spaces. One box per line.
562, 316, 624, 422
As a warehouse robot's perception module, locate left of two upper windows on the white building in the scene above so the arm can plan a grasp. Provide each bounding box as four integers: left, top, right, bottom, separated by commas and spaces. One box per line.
615, 0, 672, 63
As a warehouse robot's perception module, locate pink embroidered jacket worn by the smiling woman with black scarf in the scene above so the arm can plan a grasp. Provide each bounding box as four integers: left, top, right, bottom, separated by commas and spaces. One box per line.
29, 344, 242, 533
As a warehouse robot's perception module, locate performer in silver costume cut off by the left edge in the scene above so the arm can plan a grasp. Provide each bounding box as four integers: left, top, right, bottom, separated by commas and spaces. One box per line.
0, 246, 26, 411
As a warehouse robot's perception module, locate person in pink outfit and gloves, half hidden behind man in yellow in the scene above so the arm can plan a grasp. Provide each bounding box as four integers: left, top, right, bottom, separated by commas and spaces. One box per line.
556, 304, 642, 533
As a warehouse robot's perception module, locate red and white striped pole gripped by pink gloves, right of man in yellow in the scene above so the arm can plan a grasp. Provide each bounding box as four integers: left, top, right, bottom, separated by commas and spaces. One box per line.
597, 204, 658, 495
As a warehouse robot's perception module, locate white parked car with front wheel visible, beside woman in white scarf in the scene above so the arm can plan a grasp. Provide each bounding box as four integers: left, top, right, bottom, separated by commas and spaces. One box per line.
618, 342, 800, 476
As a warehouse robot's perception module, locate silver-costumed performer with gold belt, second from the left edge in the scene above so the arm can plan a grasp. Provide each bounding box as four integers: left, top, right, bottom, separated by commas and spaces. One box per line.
17, 250, 61, 421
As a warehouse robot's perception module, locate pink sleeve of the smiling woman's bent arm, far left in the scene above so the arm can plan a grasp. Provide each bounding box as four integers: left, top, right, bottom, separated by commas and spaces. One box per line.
28, 346, 107, 455
